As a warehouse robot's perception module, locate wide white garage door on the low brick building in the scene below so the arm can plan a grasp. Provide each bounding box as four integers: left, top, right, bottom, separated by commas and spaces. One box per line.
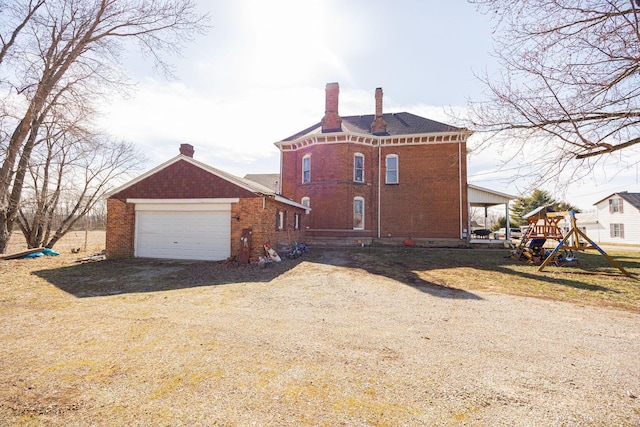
136, 205, 231, 261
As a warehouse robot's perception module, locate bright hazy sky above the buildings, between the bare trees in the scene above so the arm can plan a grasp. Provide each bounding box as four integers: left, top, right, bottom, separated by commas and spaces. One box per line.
96, 0, 640, 209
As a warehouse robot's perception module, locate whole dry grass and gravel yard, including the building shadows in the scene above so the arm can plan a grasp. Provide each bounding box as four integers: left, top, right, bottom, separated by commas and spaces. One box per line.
0, 233, 640, 426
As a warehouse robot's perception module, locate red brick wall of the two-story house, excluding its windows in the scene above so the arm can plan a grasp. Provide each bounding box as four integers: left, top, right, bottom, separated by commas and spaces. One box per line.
282, 143, 468, 239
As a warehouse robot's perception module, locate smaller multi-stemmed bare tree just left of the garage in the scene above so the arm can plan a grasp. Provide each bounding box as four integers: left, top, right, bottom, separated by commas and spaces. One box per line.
18, 108, 145, 248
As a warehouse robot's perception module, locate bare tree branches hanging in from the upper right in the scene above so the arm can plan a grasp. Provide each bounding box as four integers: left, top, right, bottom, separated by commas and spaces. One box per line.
470, 0, 640, 180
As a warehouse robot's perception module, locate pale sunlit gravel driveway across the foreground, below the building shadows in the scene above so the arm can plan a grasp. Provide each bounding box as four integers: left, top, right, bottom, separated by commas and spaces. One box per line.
0, 251, 640, 426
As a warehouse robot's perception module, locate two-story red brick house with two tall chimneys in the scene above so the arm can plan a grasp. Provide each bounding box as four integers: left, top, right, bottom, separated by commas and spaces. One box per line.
275, 83, 471, 244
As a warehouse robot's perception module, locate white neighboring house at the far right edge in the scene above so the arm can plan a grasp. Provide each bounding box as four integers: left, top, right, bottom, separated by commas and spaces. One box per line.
592, 191, 640, 245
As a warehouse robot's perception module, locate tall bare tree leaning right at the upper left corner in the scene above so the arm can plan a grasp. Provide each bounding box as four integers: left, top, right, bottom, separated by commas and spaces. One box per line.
0, 0, 207, 253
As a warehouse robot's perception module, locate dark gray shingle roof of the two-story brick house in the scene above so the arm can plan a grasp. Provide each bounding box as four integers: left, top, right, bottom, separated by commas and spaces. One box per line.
283, 113, 463, 141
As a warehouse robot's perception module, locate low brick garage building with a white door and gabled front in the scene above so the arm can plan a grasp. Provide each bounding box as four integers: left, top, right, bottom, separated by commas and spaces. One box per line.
106, 144, 307, 260
